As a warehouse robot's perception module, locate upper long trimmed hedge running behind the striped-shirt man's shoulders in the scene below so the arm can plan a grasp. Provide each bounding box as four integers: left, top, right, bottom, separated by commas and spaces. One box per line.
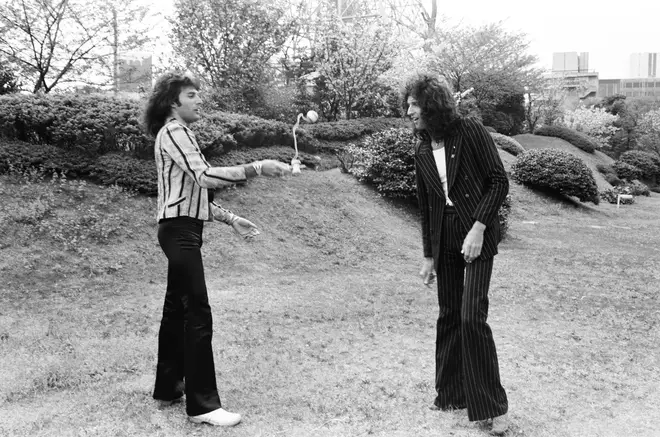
0, 95, 318, 159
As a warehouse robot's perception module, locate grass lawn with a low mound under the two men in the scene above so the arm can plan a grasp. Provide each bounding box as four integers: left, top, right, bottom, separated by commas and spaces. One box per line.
0, 165, 660, 437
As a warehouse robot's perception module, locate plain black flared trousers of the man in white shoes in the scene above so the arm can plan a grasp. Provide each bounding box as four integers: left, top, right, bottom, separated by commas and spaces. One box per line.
153, 217, 221, 416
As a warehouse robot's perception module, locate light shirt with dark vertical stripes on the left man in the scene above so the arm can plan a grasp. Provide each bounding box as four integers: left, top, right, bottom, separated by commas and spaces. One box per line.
154, 119, 247, 221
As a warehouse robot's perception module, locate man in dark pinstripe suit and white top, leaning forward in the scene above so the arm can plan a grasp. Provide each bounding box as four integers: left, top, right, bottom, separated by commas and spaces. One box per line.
403, 74, 509, 434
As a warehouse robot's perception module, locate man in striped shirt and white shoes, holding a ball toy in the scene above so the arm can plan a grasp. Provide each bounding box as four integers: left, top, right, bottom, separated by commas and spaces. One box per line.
144, 73, 291, 426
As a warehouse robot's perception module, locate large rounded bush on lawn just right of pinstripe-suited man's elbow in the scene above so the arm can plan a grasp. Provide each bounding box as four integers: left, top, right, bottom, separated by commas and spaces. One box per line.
511, 149, 599, 205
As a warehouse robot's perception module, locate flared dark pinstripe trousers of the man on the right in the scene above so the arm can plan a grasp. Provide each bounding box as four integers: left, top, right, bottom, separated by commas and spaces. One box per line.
435, 208, 508, 421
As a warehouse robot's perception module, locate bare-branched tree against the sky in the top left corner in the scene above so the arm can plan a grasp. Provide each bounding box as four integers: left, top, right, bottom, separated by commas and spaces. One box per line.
0, 0, 152, 93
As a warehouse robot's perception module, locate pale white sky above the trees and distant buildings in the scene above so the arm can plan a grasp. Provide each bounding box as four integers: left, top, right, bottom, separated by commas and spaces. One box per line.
147, 0, 660, 79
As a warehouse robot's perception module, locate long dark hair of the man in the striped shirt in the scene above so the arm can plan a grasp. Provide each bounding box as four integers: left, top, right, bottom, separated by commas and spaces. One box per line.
142, 71, 200, 138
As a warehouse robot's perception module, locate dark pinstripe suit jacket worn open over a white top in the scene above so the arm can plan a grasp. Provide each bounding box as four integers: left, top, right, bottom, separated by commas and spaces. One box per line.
415, 118, 509, 263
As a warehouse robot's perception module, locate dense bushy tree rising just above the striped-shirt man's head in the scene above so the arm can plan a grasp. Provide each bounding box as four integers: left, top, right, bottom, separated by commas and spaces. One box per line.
171, 0, 293, 94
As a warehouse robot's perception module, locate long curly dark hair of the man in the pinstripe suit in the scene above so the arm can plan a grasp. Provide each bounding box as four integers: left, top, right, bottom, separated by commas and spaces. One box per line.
401, 73, 460, 140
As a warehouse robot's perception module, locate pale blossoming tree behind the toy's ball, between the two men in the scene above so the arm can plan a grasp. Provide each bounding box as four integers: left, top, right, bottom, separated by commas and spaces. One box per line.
314, 10, 397, 120
